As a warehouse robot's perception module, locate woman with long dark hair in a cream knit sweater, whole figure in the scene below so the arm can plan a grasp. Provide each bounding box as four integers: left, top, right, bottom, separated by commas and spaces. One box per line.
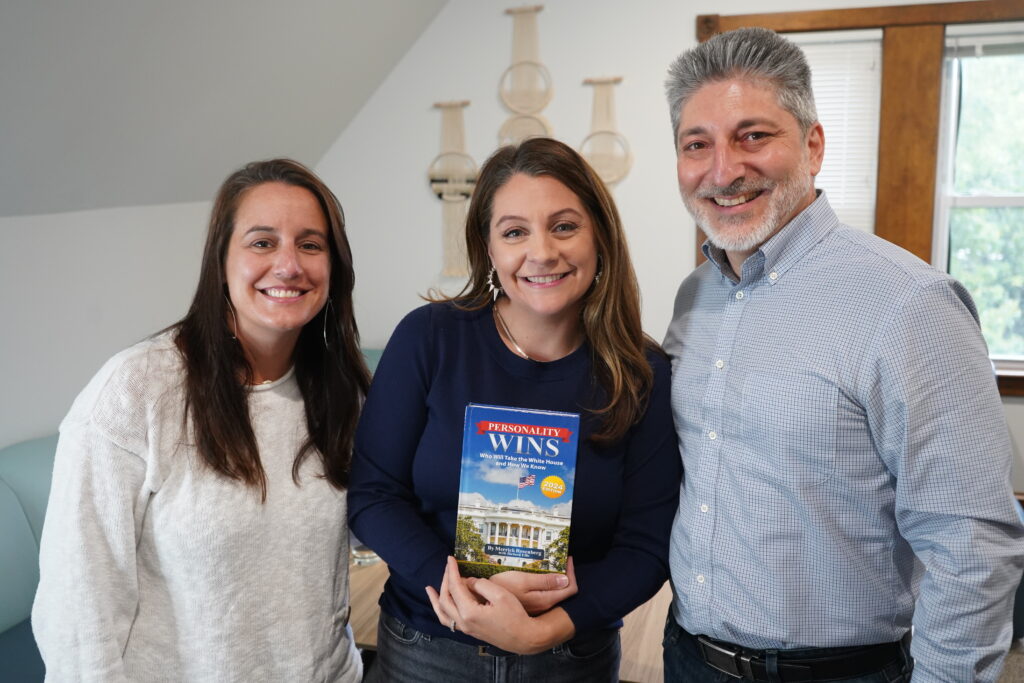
32, 160, 369, 683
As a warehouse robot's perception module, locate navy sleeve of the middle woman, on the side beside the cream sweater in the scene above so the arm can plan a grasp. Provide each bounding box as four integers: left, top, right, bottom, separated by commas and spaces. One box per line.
348, 306, 452, 590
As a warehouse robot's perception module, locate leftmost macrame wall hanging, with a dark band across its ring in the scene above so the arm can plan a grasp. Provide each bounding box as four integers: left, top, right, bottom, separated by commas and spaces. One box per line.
427, 99, 476, 278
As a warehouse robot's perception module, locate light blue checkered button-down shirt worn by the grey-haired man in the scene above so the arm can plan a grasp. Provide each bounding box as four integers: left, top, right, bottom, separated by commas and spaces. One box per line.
665, 194, 1024, 682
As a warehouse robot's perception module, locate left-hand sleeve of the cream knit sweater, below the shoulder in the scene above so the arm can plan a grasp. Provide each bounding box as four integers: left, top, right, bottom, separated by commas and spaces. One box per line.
32, 422, 148, 683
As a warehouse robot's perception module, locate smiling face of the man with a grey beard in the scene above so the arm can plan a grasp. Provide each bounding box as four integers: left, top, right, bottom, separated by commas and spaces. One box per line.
676, 78, 824, 252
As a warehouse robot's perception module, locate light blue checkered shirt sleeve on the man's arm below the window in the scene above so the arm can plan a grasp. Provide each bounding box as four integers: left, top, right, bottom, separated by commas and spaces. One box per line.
866, 281, 1024, 683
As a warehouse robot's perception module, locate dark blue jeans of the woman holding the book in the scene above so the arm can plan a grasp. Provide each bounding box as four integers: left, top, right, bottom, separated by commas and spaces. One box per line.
365, 611, 620, 683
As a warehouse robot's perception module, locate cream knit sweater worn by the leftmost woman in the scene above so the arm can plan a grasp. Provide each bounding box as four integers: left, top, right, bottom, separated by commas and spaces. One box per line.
32, 335, 361, 683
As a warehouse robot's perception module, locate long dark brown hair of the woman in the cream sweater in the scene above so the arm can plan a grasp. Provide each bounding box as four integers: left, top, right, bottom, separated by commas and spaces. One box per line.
171, 159, 370, 501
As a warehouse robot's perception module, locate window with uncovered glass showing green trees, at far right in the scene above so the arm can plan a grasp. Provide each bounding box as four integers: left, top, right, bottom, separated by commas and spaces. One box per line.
933, 24, 1024, 372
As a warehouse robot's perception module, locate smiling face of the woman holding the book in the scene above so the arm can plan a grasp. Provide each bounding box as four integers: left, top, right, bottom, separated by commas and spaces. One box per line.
487, 173, 597, 325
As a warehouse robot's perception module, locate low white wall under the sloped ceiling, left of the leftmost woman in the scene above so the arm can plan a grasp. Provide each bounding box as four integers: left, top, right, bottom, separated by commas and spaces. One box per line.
0, 203, 210, 447
